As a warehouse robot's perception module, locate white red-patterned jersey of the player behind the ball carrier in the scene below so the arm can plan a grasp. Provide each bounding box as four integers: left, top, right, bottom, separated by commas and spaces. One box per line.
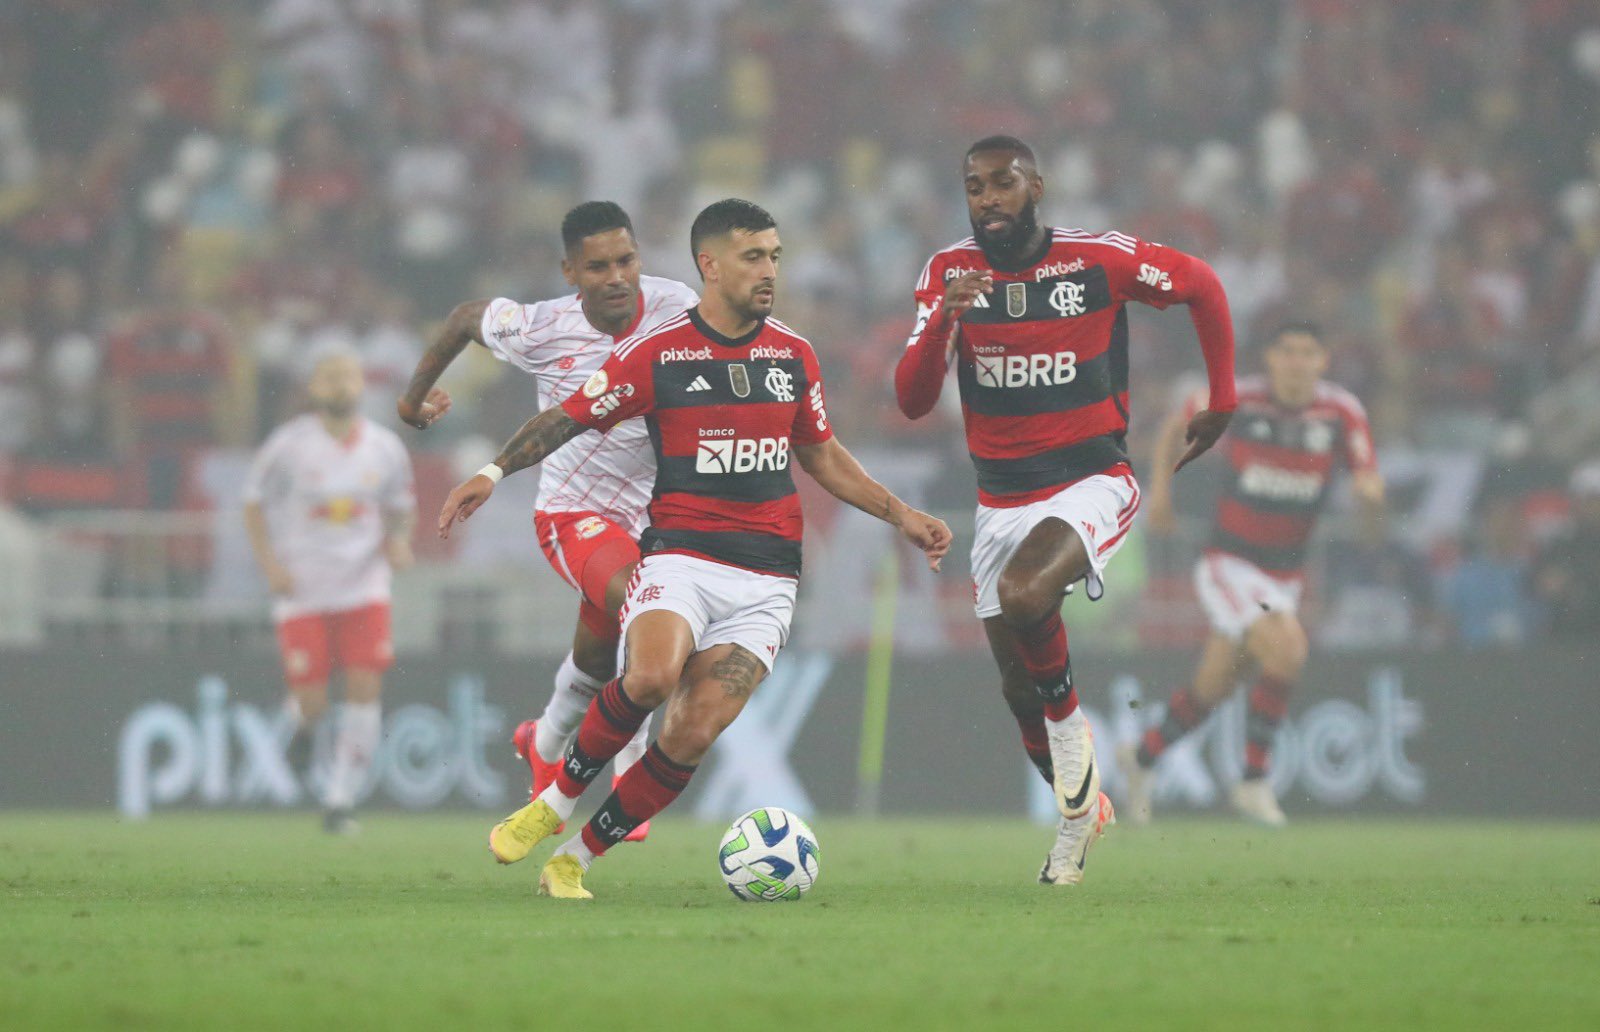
483, 275, 699, 538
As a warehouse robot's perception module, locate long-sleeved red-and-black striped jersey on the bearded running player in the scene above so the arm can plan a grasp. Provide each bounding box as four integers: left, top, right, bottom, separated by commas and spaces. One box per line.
896, 229, 1234, 507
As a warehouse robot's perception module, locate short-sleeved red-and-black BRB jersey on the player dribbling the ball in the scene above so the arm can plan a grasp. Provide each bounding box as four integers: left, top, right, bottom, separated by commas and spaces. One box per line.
562, 306, 834, 576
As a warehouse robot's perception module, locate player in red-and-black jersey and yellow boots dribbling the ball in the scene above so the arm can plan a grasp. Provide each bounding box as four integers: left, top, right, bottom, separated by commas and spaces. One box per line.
438, 200, 950, 899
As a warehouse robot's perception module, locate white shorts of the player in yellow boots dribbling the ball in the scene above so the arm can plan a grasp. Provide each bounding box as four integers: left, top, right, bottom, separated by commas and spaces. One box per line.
622, 552, 798, 670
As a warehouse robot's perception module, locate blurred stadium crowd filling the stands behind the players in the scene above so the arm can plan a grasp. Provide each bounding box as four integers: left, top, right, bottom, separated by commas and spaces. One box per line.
0, 0, 1600, 645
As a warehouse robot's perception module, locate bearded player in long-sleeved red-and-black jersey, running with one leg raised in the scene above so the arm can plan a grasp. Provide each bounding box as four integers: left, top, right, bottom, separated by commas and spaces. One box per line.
894, 136, 1234, 885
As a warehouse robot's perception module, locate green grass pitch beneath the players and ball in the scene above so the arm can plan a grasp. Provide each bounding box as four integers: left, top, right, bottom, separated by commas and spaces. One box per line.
0, 813, 1600, 1032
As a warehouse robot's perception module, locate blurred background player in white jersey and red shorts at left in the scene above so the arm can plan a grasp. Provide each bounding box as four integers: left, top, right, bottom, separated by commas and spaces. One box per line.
245, 354, 416, 834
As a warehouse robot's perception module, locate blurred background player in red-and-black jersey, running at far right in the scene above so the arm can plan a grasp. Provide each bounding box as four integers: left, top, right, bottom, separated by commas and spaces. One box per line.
1117, 323, 1384, 827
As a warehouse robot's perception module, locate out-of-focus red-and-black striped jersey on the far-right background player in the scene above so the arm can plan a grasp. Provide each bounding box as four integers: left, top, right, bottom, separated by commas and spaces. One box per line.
1184, 376, 1378, 574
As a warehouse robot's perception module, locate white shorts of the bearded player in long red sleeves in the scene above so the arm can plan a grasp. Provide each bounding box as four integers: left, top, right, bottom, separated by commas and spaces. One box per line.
973, 474, 1139, 619
